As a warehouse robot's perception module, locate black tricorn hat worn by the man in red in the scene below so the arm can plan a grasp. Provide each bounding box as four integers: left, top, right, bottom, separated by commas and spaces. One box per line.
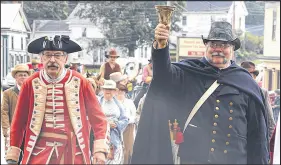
27, 35, 82, 54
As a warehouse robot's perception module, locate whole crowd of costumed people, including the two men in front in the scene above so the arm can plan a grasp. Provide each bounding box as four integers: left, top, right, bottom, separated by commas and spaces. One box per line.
1, 22, 280, 164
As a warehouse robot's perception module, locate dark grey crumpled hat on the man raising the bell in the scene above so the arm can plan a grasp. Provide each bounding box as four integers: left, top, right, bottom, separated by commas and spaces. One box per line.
202, 21, 241, 50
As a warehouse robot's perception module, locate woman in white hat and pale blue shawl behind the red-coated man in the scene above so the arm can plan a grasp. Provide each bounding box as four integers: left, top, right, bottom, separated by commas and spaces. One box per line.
98, 80, 129, 164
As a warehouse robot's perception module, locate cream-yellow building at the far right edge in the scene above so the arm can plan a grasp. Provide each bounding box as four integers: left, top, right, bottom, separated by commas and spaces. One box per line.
260, 1, 280, 90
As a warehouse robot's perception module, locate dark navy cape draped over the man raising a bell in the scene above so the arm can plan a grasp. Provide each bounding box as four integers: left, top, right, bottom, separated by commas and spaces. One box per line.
131, 46, 268, 164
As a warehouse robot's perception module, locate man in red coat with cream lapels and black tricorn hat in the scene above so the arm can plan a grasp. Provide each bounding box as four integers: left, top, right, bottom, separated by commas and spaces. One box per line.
6, 36, 109, 164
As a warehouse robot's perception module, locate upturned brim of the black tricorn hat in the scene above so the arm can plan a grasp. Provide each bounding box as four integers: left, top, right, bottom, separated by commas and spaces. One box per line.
27, 36, 82, 54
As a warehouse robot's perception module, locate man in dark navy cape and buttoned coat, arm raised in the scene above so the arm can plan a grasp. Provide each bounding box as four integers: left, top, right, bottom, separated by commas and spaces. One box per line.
131, 22, 269, 164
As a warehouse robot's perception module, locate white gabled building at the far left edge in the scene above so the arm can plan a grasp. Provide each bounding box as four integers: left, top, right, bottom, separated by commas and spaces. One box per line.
1, 3, 31, 80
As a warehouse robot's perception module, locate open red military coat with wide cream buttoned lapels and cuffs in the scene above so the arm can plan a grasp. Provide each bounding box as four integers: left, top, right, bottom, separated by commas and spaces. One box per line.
6, 70, 109, 164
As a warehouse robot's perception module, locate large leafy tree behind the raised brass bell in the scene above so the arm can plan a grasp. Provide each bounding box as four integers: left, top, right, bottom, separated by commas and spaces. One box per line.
77, 1, 184, 57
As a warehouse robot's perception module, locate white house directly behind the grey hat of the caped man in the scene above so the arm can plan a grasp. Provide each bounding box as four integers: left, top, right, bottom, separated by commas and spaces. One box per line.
173, 1, 248, 37
